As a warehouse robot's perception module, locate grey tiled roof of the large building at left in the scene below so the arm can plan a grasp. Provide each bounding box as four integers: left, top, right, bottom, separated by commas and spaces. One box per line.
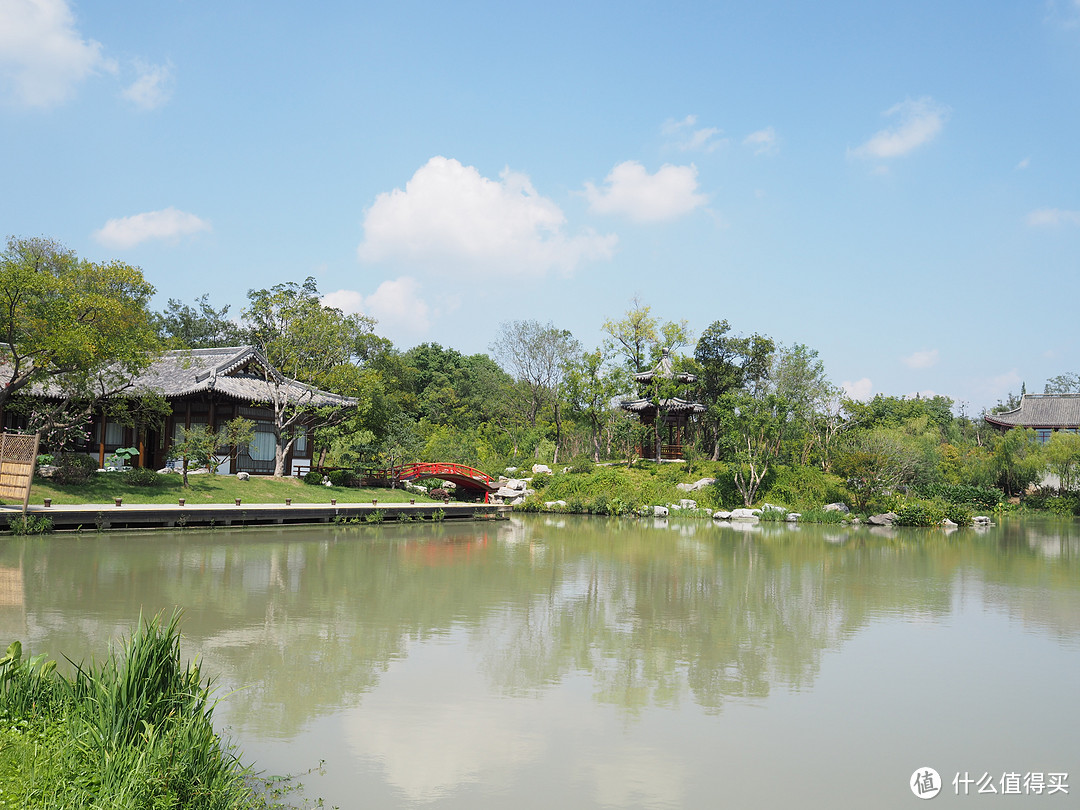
11, 346, 356, 407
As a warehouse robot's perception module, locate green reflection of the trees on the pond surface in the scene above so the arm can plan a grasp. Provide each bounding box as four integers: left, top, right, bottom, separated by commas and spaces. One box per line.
0, 516, 1080, 738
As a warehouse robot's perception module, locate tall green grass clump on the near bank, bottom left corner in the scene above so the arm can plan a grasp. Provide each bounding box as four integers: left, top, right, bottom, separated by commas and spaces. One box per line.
0, 611, 261, 810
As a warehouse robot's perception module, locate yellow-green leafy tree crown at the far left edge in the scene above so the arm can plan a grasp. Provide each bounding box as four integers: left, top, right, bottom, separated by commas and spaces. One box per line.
0, 237, 161, 409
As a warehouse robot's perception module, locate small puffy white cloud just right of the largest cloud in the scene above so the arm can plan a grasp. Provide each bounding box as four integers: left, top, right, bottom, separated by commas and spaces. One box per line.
585, 160, 708, 222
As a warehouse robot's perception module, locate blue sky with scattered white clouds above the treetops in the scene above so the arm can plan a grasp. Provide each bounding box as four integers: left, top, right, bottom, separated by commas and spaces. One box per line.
0, 0, 1080, 413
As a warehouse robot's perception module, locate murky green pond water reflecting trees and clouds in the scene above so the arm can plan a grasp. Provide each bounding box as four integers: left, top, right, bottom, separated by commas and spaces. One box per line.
0, 516, 1080, 808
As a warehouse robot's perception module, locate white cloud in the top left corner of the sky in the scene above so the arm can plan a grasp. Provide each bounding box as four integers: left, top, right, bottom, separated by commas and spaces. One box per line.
0, 0, 117, 107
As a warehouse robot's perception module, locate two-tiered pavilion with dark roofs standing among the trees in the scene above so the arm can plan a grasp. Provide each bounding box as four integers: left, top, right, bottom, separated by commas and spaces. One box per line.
619, 349, 705, 460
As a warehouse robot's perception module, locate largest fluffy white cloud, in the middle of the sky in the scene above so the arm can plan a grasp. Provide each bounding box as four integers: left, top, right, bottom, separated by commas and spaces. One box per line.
357, 157, 618, 273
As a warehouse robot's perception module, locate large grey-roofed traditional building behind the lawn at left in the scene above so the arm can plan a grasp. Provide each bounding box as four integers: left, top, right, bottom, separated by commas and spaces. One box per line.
2, 346, 356, 474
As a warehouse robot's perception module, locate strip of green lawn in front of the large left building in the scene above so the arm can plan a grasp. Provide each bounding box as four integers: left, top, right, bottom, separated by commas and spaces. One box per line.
14, 473, 434, 505
